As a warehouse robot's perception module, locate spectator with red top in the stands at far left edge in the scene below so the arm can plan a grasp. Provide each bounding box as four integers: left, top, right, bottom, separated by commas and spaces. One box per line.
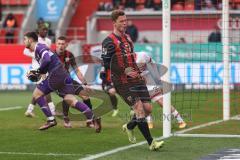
3, 13, 17, 43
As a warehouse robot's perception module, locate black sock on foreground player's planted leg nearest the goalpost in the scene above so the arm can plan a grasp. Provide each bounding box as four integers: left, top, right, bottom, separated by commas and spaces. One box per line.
137, 118, 153, 145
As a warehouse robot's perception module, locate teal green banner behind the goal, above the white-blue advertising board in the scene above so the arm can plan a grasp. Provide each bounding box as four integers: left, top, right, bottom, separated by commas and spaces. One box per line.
135, 43, 240, 63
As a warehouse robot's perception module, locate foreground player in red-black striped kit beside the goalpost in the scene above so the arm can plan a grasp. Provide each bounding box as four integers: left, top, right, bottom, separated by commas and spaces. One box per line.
102, 10, 164, 150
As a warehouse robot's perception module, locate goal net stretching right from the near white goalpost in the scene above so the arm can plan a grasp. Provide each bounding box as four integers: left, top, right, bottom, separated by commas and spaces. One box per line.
160, 0, 240, 137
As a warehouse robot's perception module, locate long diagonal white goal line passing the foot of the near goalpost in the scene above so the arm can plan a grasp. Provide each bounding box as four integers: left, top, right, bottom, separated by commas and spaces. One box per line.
79, 115, 239, 160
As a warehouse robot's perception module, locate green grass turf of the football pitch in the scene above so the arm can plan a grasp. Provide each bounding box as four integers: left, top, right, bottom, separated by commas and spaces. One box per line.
0, 92, 240, 160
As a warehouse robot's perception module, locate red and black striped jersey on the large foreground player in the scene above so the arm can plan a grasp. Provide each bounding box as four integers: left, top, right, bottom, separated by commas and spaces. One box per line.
102, 33, 141, 83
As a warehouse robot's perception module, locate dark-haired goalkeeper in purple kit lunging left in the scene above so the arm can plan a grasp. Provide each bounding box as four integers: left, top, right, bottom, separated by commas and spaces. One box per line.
24, 32, 101, 132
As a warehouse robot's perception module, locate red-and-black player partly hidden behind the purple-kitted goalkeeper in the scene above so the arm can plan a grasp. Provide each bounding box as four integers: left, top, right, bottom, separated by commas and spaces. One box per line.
54, 36, 100, 131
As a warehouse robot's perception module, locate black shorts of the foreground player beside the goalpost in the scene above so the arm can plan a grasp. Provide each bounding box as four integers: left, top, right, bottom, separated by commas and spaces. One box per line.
114, 82, 151, 106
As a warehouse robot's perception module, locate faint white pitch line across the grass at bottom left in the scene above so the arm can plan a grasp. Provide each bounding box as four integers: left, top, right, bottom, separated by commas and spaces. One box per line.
0, 152, 82, 157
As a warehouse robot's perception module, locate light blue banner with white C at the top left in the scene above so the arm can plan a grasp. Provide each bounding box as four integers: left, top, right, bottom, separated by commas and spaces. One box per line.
37, 0, 66, 22
